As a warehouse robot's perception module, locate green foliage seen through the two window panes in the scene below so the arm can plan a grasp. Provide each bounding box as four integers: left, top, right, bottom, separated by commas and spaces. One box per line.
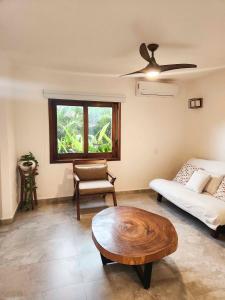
57, 105, 112, 154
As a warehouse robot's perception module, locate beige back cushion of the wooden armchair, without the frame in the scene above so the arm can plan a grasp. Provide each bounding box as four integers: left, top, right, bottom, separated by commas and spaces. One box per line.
74, 164, 107, 181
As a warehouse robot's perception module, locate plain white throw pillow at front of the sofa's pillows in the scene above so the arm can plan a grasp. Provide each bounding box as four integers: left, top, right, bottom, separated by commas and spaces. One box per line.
186, 170, 211, 193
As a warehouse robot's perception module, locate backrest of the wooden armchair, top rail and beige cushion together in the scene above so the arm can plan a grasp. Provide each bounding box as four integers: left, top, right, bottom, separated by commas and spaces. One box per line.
73, 159, 108, 181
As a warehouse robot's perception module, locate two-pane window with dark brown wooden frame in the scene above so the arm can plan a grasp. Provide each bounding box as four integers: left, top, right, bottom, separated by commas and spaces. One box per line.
49, 99, 120, 163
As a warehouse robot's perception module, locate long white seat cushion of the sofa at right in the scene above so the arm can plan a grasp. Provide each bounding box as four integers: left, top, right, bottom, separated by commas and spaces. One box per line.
149, 179, 225, 230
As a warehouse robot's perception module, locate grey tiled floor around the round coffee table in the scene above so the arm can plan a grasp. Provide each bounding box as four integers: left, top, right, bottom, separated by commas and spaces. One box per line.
0, 193, 225, 300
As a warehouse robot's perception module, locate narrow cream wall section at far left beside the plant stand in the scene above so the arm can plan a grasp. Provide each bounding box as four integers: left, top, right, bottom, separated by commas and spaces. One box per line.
0, 59, 17, 219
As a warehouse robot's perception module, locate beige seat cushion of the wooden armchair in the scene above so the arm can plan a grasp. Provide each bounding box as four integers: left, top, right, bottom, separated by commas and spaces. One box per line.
79, 180, 114, 195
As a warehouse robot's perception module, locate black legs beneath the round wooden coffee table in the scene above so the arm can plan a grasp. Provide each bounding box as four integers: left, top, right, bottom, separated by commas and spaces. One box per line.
101, 254, 152, 289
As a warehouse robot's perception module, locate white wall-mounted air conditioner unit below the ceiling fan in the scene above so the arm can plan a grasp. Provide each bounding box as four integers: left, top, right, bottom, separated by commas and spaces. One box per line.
136, 81, 178, 97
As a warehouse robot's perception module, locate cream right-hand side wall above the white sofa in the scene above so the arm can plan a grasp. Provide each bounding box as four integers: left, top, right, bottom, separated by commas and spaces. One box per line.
185, 71, 225, 161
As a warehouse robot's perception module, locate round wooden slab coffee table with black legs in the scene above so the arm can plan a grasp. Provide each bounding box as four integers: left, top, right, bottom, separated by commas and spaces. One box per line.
92, 206, 178, 289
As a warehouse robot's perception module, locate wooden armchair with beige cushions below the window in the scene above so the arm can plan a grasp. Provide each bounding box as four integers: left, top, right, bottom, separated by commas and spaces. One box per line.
73, 159, 117, 220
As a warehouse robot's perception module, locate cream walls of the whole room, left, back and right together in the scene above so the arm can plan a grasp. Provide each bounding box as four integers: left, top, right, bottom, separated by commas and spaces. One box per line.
0, 63, 225, 219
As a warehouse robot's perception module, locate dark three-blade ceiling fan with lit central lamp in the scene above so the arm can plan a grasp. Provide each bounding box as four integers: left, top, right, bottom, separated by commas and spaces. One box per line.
122, 43, 197, 78
